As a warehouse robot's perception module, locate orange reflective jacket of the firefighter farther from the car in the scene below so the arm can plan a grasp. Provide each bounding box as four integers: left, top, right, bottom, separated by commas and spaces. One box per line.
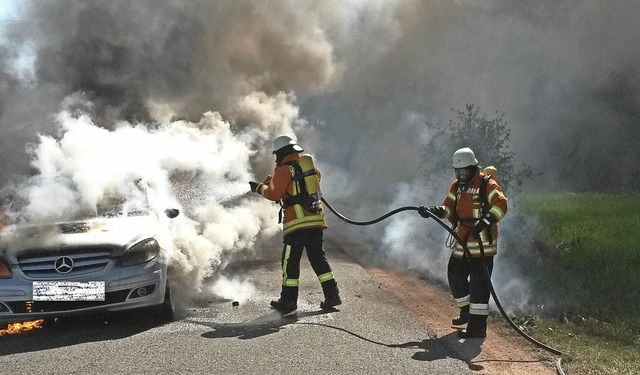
442, 172, 507, 258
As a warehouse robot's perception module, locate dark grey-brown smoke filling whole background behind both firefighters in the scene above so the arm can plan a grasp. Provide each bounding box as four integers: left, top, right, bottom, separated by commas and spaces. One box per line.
0, 0, 640, 312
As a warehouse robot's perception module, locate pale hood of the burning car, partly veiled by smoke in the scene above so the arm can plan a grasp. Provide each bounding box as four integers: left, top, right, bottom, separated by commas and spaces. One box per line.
0, 216, 158, 255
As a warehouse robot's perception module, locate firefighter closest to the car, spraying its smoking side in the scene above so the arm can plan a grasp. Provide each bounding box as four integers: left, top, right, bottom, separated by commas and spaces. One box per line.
249, 134, 342, 313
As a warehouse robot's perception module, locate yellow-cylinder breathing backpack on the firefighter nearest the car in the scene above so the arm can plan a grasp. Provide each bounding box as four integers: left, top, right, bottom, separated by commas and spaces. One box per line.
282, 154, 322, 214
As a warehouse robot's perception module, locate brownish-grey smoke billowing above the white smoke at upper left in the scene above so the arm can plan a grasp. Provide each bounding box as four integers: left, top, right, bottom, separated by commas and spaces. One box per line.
0, 0, 339, 181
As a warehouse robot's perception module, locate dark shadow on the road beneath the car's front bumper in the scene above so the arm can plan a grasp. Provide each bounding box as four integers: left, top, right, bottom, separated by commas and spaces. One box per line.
0, 311, 160, 356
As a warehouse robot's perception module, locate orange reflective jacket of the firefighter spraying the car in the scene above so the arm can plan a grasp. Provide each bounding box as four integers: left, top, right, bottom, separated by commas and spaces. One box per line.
258, 152, 327, 235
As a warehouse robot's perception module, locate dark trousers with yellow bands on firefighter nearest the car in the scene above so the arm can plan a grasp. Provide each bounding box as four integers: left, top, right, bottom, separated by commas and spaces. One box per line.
280, 228, 338, 301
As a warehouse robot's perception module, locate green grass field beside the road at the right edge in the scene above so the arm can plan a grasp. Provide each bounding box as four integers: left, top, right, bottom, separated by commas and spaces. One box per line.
516, 193, 640, 317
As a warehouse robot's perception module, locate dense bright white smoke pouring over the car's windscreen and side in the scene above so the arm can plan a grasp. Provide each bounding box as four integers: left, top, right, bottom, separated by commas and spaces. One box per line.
13, 95, 297, 302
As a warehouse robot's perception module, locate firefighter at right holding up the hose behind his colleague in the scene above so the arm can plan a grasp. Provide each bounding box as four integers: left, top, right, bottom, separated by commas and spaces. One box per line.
418, 147, 507, 338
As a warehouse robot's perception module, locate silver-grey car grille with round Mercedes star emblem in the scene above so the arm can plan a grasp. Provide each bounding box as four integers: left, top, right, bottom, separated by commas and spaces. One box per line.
18, 247, 112, 280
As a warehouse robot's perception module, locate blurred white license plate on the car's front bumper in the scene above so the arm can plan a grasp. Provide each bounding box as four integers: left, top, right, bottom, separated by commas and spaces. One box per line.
33, 281, 105, 301
